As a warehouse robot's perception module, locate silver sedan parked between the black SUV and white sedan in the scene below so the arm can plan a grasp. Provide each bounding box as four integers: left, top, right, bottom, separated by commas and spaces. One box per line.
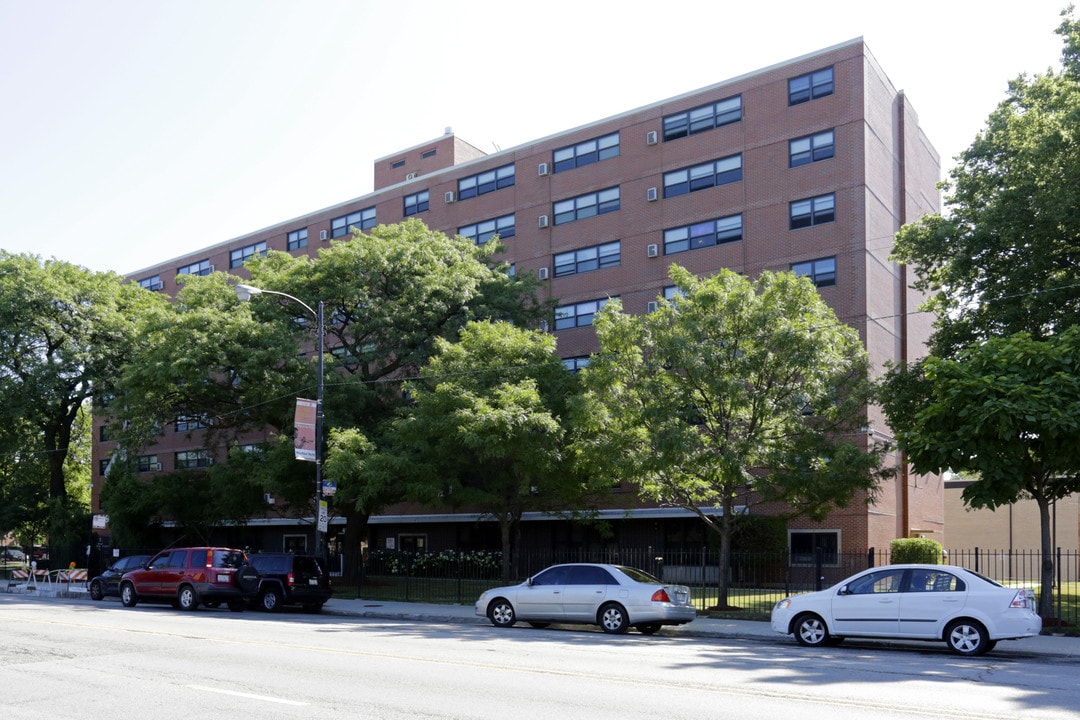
476, 563, 698, 635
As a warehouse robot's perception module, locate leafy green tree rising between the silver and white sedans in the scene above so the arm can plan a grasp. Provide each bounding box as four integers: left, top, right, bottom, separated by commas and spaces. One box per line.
578, 266, 883, 604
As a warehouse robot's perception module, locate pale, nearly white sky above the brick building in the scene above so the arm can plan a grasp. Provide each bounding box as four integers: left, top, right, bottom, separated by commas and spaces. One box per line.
0, 0, 1065, 273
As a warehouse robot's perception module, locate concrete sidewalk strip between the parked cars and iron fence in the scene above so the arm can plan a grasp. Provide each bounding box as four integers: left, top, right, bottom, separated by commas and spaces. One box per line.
323, 598, 1080, 662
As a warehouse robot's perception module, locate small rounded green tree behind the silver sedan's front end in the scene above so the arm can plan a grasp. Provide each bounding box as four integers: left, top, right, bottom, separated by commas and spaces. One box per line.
388, 322, 591, 580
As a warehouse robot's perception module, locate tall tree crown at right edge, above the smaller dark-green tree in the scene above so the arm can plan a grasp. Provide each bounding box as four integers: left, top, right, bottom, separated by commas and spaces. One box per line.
894, 8, 1080, 357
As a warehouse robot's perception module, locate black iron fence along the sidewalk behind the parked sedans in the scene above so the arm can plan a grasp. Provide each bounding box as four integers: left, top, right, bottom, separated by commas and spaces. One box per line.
359, 547, 1080, 626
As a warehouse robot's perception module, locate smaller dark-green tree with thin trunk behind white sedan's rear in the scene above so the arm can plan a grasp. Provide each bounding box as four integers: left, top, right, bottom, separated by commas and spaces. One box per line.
882, 326, 1080, 617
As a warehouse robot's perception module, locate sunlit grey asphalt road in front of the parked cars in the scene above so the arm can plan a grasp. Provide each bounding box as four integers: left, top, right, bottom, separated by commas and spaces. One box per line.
0, 596, 1080, 720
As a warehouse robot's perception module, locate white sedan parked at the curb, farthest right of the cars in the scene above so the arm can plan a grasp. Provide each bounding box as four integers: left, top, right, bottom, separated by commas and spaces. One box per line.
772, 565, 1042, 655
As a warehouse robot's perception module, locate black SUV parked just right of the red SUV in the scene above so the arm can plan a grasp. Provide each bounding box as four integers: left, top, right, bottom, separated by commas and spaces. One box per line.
248, 553, 334, 612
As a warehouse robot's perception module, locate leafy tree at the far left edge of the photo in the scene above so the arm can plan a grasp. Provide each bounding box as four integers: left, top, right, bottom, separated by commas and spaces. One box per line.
0, 250, 161, 544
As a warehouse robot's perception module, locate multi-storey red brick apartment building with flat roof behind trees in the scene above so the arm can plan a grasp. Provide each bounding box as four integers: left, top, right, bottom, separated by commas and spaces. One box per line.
94, 39, 944, 569
